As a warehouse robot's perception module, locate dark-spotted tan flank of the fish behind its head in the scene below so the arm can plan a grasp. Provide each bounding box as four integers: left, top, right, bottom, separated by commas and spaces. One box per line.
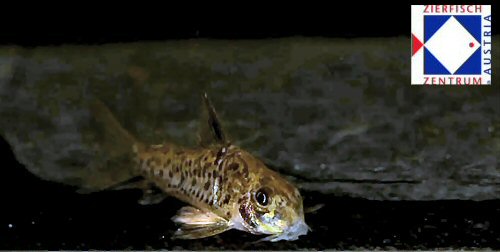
137, 145, 252, 218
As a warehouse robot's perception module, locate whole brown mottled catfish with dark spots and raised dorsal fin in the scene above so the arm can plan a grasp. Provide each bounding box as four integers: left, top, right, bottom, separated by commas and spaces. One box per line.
93, 94, 309, 241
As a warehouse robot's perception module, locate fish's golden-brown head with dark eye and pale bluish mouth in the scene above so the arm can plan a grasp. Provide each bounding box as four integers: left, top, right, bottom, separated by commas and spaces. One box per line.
231, 150, 309, 241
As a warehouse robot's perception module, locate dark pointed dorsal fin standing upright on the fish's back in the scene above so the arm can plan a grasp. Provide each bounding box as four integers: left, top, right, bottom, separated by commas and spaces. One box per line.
198, 93, 228, 146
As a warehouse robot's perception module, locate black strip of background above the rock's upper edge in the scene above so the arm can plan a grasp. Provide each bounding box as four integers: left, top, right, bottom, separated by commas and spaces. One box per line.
0, 0, 498, 46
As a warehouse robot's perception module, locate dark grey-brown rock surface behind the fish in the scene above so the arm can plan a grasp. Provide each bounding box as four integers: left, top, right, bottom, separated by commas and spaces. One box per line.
0, 37, 500, 200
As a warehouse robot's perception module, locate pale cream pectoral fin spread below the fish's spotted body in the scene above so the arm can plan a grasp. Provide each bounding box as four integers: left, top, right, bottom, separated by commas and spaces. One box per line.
172, 206, 231, 239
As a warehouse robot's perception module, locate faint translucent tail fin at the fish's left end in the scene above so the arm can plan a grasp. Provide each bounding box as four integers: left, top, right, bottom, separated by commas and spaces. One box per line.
79, 99, 144, 193
